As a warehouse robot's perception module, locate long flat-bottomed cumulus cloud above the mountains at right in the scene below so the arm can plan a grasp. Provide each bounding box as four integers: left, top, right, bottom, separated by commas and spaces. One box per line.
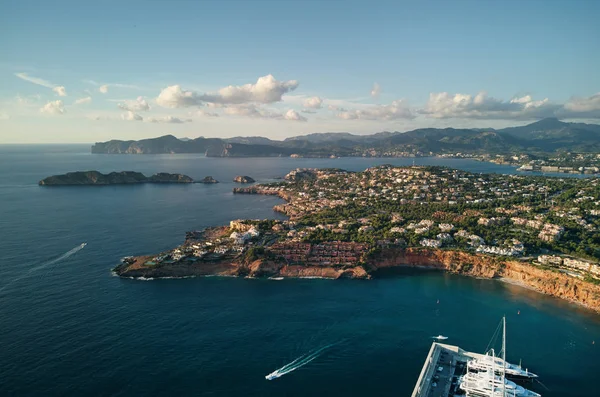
419, 92, 560, 120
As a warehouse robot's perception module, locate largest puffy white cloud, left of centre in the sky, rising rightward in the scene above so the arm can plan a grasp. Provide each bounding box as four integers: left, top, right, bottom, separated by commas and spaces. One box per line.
156, 75, 298, 108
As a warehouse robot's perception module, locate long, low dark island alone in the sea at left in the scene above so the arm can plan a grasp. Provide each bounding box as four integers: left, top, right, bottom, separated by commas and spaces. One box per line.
39, 171, 194, 186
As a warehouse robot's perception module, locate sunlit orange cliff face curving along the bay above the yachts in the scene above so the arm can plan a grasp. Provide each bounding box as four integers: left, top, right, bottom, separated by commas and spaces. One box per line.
368, 248, 600, 311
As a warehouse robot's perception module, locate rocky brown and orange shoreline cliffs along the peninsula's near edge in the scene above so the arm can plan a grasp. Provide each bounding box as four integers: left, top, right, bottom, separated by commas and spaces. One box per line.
114, 248, 600, 312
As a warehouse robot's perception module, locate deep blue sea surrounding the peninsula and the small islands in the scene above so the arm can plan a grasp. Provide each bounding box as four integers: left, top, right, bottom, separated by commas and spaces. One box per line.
0, 145, 600, 397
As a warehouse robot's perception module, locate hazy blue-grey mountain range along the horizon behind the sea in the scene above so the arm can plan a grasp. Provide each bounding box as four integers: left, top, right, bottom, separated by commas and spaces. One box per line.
92, 118, 600, 157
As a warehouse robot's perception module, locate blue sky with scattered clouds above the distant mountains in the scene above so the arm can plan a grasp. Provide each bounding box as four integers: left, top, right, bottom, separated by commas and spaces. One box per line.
0, 0, 600, 143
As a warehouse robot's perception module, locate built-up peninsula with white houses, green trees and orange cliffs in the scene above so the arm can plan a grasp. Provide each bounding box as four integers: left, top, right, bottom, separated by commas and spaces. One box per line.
114, 165, 600, 311
